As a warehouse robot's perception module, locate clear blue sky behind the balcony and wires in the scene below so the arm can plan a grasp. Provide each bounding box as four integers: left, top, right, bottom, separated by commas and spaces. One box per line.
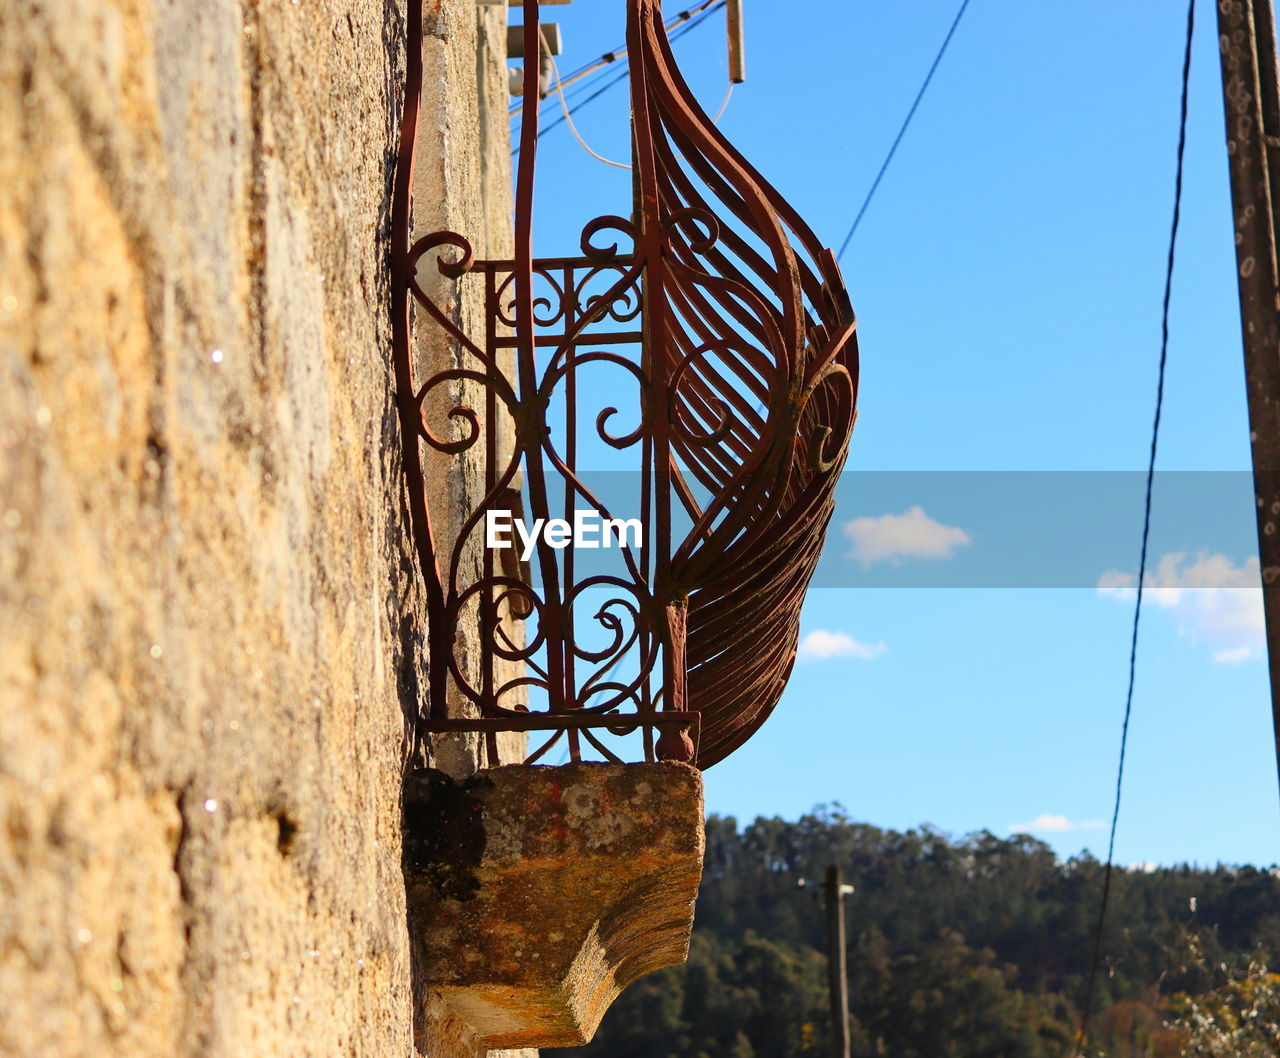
504, 0, 1280, 864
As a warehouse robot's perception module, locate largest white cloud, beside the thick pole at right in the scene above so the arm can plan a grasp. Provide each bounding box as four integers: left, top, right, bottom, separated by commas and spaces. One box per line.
1098, 551, 1266, 665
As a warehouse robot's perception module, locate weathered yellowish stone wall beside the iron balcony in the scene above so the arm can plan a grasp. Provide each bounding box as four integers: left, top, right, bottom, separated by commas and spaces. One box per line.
0, 0, 519, 1058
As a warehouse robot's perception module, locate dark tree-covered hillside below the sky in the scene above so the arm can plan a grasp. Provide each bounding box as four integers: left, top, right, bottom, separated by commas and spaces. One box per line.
545, 809, 1280, 1058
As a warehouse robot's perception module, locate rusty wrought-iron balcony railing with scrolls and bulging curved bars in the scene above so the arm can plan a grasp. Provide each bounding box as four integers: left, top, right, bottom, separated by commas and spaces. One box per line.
392, 0, 858, 768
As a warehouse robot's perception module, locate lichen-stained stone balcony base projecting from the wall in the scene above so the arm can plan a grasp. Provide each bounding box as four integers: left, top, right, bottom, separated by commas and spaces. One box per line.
404, 764, 703, 1046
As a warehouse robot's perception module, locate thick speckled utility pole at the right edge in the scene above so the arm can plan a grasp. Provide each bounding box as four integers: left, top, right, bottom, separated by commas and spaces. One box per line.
1217, 0, 1280, 798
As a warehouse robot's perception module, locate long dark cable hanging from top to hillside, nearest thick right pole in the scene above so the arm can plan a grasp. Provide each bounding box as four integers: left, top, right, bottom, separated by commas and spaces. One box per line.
1076, 0, 1196, 1055
